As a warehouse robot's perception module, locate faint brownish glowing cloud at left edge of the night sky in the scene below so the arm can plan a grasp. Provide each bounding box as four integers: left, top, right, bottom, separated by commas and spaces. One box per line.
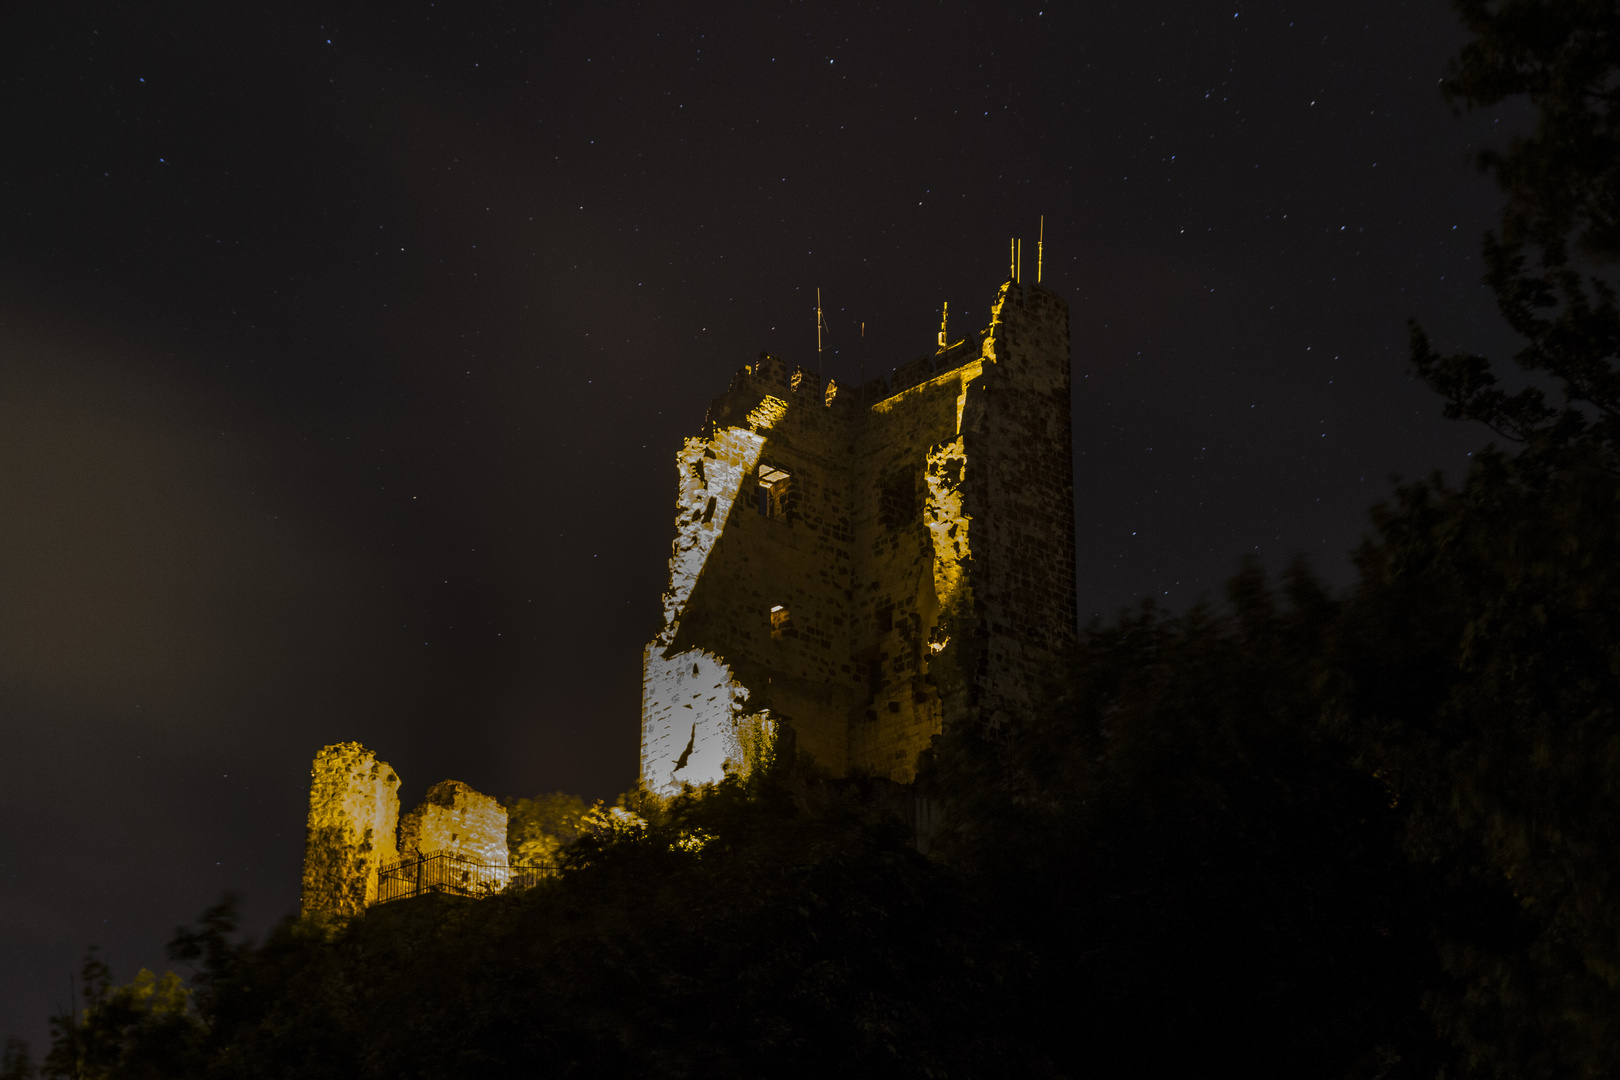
0, 306, 366, 727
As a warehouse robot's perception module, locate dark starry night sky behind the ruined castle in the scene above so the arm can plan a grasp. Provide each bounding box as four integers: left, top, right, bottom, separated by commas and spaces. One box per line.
0, 0, 1523, 1046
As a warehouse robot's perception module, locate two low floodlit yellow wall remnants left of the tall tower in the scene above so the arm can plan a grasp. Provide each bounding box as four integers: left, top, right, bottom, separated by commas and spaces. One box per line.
301, 743, 509, 918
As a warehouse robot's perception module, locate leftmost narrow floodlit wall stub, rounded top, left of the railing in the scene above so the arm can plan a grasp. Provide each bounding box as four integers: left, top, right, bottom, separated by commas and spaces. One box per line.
303, 743, 400, 916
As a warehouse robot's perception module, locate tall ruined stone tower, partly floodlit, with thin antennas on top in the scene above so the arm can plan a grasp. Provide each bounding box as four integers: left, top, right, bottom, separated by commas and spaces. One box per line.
642, 282, 1076, 793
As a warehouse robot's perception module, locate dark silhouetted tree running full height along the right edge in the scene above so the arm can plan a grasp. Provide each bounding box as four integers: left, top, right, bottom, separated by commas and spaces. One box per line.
1393, 0, 1620, 1077
